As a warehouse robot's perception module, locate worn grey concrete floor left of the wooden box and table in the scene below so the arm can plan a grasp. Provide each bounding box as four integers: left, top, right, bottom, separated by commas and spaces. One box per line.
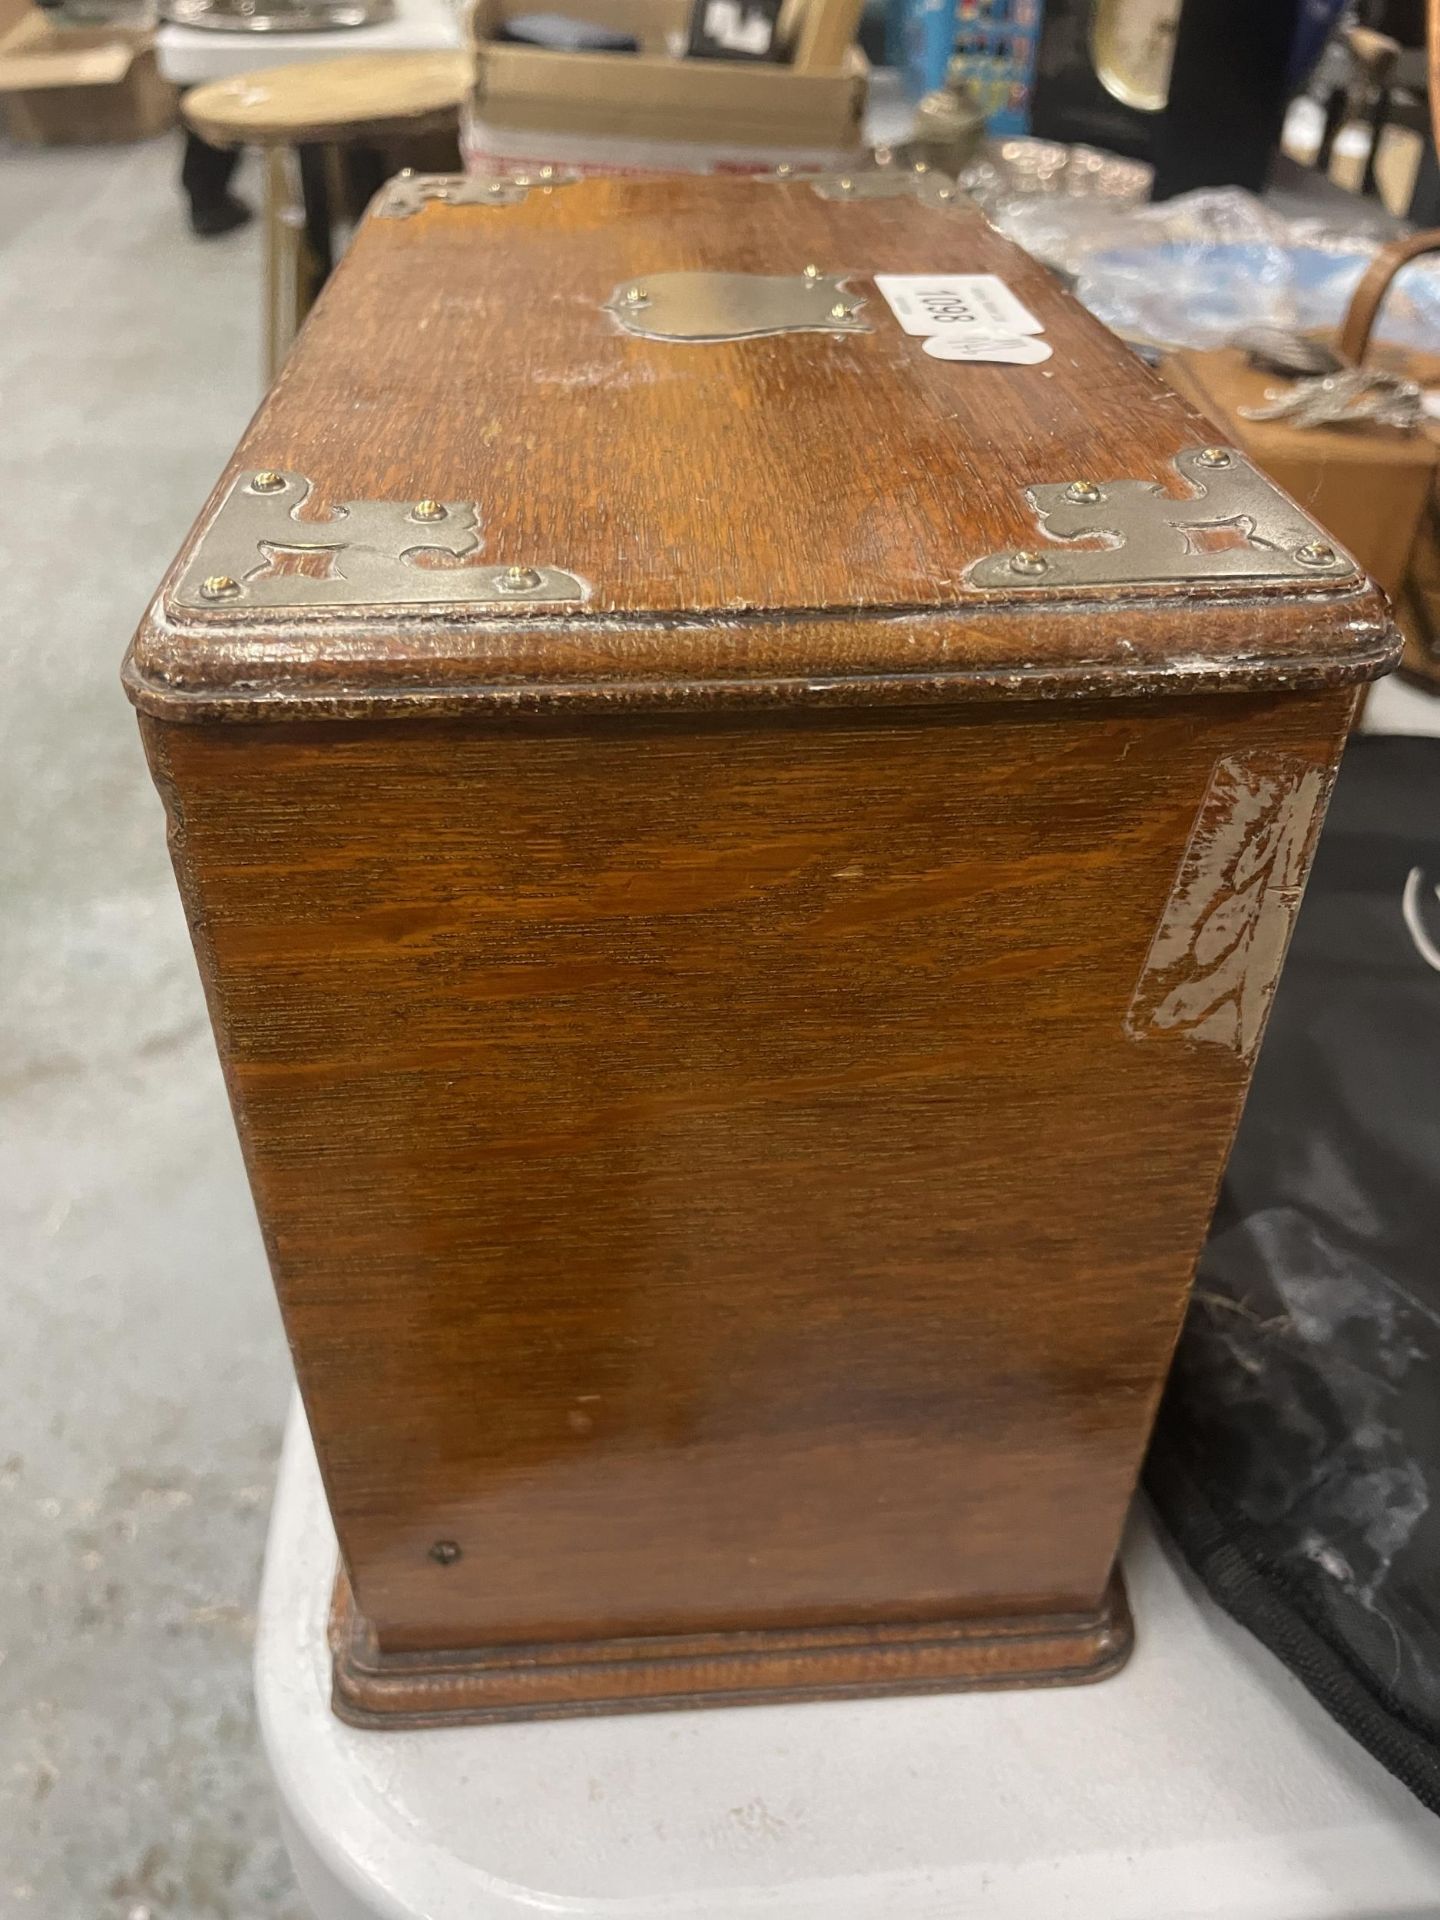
0, 140, 303, 1920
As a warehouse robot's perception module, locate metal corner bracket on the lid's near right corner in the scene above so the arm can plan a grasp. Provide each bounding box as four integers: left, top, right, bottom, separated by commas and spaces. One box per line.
970, 447, 1359, 593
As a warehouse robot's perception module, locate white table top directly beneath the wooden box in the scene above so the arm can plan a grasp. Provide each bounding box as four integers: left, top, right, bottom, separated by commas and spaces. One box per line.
255, 1413, 1440, 1920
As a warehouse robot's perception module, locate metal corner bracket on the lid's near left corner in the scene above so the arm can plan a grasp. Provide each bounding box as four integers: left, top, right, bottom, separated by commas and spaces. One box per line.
169, 468, 588, 611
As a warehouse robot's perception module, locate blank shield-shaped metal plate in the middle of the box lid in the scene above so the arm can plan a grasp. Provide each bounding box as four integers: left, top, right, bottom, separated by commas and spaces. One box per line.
605, 267, 870, 344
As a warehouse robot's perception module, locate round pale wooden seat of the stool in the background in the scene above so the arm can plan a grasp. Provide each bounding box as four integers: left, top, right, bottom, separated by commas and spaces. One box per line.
182, 52, 472, 146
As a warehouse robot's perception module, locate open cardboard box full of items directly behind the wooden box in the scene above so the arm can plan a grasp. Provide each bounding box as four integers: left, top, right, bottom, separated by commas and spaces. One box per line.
472, 0, 870, 171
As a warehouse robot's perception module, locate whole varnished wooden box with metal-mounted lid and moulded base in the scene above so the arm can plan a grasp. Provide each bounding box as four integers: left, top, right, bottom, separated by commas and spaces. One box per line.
127, 177, 1396, 1722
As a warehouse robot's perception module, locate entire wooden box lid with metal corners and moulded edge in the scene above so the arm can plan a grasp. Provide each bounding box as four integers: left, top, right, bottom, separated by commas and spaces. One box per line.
127, 177, 1394, 718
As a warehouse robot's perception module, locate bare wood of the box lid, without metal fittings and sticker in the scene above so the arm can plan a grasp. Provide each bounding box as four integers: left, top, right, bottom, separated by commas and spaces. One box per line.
131, 167, 1396, 720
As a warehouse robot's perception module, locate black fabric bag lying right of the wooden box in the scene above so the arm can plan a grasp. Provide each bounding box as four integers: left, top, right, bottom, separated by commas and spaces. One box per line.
1146, 735, 1440, 1812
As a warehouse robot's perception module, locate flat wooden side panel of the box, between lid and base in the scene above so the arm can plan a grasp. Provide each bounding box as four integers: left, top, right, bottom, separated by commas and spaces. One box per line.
146, 693, 1350, 1651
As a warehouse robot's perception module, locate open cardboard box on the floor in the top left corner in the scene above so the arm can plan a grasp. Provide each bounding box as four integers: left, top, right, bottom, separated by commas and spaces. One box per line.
0, 8, 177, 146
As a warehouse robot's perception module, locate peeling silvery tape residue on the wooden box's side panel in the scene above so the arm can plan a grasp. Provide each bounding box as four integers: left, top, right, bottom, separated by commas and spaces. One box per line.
1125, 753, 1329, 1060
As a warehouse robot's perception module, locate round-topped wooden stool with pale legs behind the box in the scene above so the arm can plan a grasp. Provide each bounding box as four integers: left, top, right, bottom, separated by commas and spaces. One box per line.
182, 52, 472, 378
